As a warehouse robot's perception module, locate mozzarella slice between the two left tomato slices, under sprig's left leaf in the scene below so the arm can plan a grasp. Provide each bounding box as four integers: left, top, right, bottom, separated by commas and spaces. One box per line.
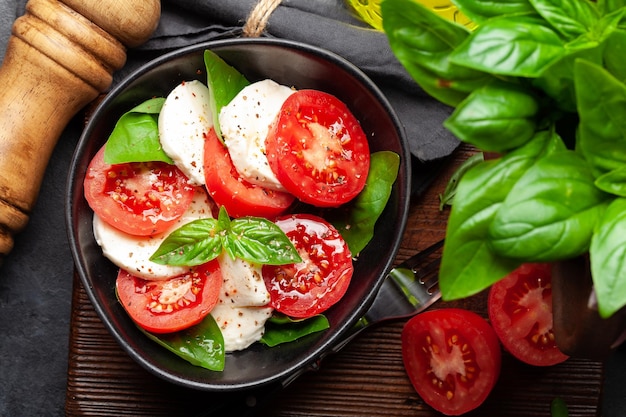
93, 189, 213, 280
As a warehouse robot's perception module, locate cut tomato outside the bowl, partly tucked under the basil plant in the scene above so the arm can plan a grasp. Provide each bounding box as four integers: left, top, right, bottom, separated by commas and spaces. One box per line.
488, 263, 568, 366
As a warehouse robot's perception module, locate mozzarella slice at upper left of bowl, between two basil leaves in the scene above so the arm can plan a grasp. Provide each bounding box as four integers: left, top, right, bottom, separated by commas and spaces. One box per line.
158, 80, 213, 185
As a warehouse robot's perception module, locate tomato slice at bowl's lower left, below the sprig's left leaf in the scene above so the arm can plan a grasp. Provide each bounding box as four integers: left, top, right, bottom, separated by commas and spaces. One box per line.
116, 261, 222, 333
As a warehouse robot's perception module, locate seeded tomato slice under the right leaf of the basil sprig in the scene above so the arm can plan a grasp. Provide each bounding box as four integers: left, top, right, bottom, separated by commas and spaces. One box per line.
262, 214, 354, 318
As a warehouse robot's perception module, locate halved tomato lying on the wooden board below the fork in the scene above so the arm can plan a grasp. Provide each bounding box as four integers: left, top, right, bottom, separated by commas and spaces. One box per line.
402, 308, 501, 415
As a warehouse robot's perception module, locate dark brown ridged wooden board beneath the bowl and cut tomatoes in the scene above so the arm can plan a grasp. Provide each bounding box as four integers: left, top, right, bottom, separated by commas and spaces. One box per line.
66, 147, 604, 417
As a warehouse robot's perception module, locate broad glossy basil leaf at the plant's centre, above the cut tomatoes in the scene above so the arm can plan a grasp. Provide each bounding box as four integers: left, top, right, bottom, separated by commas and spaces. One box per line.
489, 150, 608, 262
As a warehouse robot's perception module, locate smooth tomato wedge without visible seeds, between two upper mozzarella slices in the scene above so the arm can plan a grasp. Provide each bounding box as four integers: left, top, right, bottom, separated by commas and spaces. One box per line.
204, 129, 295, 218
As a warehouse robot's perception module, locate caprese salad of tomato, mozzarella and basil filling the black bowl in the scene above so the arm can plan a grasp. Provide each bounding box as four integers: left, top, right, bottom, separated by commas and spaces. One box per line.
84, 51, 399, 370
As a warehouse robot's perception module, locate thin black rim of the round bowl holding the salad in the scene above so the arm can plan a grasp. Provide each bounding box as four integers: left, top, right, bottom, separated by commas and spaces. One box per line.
65, 38, 412, 392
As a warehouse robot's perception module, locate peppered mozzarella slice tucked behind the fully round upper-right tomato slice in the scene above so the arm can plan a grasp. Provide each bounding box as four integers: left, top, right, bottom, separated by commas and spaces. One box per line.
219, 80, 294, 191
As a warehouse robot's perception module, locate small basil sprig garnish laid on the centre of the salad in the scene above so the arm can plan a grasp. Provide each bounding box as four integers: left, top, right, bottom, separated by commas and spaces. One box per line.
150, 207, 302, 266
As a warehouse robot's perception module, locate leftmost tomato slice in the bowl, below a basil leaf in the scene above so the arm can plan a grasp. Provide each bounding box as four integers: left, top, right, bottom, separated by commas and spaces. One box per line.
84, 147, 194, 236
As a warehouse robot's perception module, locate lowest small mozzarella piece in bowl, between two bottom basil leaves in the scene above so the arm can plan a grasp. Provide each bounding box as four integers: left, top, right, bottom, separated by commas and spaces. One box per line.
211, 304, 273, 352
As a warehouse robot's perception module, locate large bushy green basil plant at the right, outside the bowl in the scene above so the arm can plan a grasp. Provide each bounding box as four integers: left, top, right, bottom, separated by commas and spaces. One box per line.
381, 0, 626, 317
